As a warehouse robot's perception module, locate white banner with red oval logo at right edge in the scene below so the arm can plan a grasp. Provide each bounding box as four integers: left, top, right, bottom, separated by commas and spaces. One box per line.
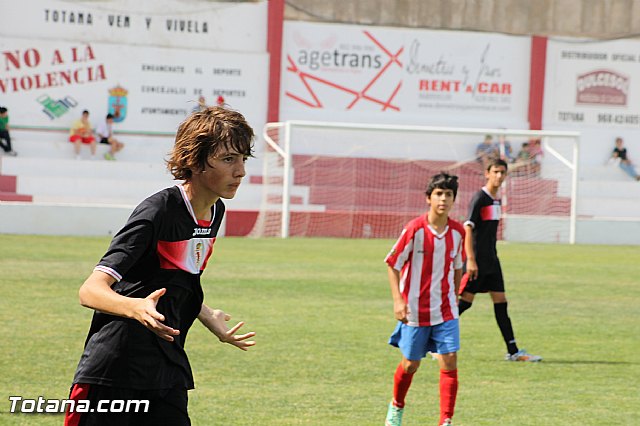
544, 40, 640, 129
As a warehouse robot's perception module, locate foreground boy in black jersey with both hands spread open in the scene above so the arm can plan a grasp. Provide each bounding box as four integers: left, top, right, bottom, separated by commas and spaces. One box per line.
65, 107, 255, 426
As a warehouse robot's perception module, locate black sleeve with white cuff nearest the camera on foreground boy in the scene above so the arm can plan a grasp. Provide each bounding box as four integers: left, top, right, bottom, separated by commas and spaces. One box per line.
94, 200, 162, 281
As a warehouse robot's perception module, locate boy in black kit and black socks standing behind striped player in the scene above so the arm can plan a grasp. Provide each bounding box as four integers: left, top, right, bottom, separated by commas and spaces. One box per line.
458, 159, 542, 362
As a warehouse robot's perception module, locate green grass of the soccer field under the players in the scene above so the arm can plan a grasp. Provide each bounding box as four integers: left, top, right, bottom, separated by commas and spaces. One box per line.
0, 235, 640, 426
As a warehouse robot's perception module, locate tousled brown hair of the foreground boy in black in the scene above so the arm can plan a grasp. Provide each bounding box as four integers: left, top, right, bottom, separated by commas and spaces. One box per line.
167, 106, 254, 180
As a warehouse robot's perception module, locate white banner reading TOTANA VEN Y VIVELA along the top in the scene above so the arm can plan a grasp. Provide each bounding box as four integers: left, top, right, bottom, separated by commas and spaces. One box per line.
0, 0, 267, 52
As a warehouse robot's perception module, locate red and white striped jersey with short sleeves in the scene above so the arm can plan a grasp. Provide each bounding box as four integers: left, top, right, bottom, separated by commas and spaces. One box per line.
385, 215, 465, 327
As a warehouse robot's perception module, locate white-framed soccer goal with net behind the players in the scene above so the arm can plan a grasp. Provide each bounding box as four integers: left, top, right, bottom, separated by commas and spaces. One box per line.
250, 121, 579, 243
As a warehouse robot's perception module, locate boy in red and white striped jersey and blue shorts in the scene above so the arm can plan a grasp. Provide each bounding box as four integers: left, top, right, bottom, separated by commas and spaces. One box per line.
385, 173, 464, 426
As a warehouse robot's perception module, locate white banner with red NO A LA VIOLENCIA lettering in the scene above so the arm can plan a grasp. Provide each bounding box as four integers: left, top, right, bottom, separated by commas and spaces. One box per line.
0, 38, 268, 132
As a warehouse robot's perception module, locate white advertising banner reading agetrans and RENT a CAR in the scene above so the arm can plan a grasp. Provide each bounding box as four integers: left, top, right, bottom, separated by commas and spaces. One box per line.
280, 22, 531, 127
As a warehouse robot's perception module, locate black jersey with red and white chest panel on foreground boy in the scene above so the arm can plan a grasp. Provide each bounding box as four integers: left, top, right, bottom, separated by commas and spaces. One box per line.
73, 185, 224, 389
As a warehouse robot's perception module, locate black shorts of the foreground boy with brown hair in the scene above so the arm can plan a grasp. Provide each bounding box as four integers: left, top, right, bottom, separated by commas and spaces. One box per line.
64, 383, 191, 426
